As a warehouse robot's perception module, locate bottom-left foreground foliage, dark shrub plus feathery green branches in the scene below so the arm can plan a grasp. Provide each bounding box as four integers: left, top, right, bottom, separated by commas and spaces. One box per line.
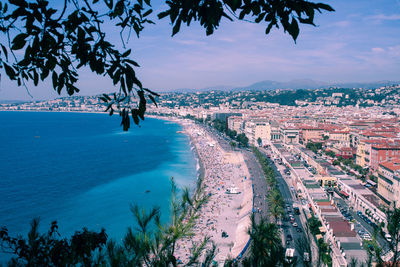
0, 182, 216, 267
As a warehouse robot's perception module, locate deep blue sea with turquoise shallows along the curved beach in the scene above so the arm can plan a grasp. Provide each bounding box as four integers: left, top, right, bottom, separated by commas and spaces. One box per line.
0, 111, 198, 259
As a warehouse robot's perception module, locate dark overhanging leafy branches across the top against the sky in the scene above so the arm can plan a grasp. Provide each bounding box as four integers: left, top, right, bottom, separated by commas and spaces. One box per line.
0, 0, 334, 130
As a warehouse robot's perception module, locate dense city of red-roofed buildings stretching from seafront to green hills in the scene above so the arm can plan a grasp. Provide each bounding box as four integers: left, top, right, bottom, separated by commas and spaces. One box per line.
0, 85, 400, 266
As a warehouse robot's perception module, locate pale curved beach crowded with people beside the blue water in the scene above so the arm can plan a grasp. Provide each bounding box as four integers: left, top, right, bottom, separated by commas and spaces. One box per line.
170, 120, 253, 263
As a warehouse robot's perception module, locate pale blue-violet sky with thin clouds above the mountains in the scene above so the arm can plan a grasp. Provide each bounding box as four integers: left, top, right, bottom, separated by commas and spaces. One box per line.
0, 0, 400, 100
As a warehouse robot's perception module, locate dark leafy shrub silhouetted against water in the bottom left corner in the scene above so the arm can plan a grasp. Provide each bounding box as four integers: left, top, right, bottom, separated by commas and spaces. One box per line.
0, 219, 107, 266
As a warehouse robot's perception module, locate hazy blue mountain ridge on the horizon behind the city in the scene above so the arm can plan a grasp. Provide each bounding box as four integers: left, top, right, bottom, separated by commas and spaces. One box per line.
174, 79, 400, 92
